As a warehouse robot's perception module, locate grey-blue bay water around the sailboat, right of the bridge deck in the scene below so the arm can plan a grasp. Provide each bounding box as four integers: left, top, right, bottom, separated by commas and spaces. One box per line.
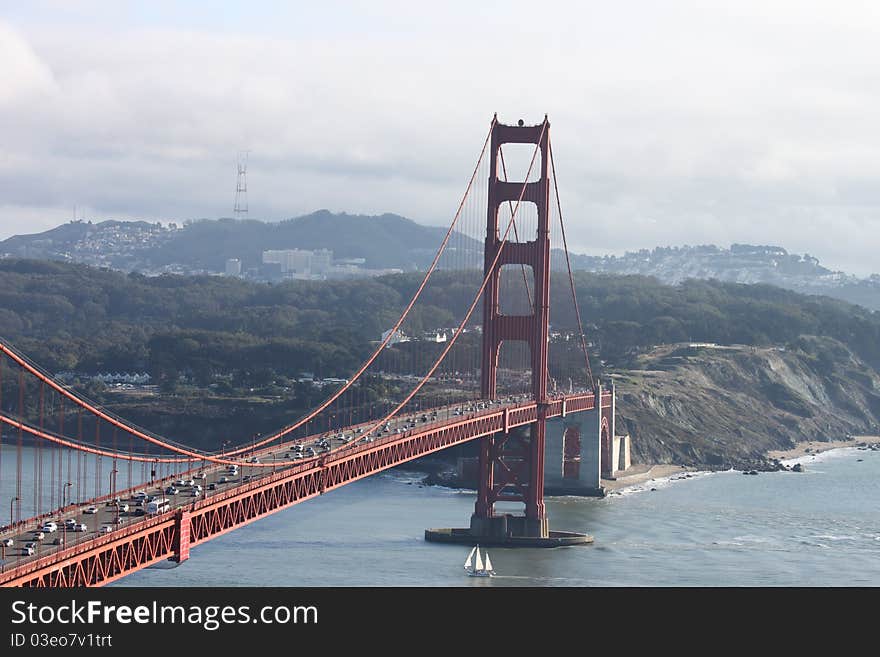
114, 448, 880, 587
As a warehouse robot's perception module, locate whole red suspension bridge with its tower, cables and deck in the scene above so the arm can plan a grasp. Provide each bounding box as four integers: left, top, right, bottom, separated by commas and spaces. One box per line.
0, 116, 613, 586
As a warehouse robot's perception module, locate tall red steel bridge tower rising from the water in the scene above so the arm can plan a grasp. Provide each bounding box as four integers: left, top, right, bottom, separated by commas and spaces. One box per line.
471, 117, 550, 538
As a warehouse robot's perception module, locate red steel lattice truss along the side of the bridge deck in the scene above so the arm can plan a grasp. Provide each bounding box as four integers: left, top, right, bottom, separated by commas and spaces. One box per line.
0, 393, 610, 587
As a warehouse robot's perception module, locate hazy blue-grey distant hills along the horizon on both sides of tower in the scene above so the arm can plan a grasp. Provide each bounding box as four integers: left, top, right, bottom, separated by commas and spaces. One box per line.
0, 210, 880, 310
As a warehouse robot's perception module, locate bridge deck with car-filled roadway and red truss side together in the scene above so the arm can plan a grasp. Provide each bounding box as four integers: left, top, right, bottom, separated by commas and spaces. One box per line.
0, 392, 610, 586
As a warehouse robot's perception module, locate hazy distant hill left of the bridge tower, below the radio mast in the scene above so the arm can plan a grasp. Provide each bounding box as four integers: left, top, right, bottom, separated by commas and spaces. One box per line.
0, 210, 482, 273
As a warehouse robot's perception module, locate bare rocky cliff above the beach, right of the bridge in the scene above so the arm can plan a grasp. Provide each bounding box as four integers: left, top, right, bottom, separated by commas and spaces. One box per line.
613, 337, 880, 468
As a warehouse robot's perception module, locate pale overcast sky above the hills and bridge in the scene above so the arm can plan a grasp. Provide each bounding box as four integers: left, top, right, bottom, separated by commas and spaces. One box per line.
0, 0, 880, 275
